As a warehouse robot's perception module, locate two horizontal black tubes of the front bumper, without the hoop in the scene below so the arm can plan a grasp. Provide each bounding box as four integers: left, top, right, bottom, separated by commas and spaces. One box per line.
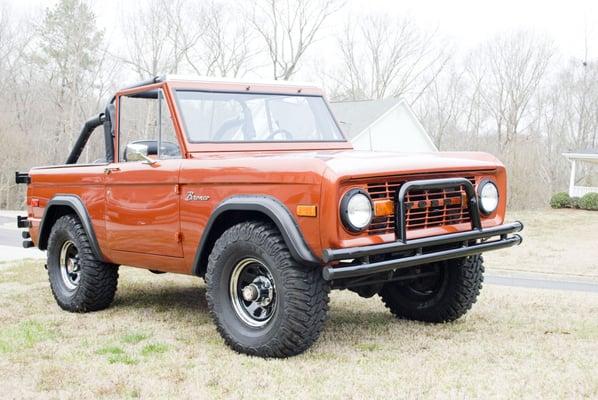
322, 221, 523, 280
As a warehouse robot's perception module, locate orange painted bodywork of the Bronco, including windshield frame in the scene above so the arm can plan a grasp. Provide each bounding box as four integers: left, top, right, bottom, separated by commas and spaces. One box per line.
27, 80, 507, 274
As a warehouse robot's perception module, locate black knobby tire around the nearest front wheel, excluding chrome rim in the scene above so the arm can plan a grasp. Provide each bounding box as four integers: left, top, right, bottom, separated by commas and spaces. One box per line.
205, 221, 330, 357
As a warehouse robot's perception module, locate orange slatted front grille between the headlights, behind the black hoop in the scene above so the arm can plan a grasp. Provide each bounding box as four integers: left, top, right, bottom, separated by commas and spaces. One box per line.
367, 176, 475, 235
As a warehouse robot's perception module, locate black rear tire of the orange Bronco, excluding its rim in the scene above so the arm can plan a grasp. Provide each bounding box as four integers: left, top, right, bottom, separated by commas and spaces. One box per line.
48, 214, 118, 312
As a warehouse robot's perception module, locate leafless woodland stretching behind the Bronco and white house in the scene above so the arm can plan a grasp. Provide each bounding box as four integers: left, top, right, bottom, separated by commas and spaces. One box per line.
0, 0, 598, 209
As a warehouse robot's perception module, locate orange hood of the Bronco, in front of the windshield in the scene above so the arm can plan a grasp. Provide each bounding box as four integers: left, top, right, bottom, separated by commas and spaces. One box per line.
186, 150, 502, 184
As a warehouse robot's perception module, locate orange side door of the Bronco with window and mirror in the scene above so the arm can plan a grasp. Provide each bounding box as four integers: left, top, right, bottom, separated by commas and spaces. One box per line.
106, 89, 183, 257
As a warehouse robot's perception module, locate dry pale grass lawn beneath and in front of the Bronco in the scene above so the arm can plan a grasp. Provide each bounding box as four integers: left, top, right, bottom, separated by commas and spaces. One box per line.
0, 262, 598, 399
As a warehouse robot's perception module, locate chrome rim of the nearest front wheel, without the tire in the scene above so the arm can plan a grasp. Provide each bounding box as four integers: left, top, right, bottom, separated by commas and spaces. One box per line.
229, 258, 276, 327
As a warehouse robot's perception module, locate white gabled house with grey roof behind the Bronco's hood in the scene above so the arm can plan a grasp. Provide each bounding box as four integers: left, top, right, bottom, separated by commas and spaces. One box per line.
330, 98, 438, 152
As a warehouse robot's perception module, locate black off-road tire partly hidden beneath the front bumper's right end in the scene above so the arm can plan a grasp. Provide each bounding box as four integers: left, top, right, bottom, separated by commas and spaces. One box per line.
379, 255, 484, 322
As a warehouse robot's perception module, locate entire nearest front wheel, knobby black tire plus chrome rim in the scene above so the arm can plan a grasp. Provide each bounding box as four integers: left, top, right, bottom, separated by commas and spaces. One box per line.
206, 221, 329, 357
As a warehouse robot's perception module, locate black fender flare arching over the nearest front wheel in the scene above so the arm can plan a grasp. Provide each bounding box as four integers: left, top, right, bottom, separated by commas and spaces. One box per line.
193, 195, 322, 275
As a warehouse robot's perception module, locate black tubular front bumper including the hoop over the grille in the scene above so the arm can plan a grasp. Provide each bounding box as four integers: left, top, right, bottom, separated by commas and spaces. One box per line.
322, 178, 523, 281
